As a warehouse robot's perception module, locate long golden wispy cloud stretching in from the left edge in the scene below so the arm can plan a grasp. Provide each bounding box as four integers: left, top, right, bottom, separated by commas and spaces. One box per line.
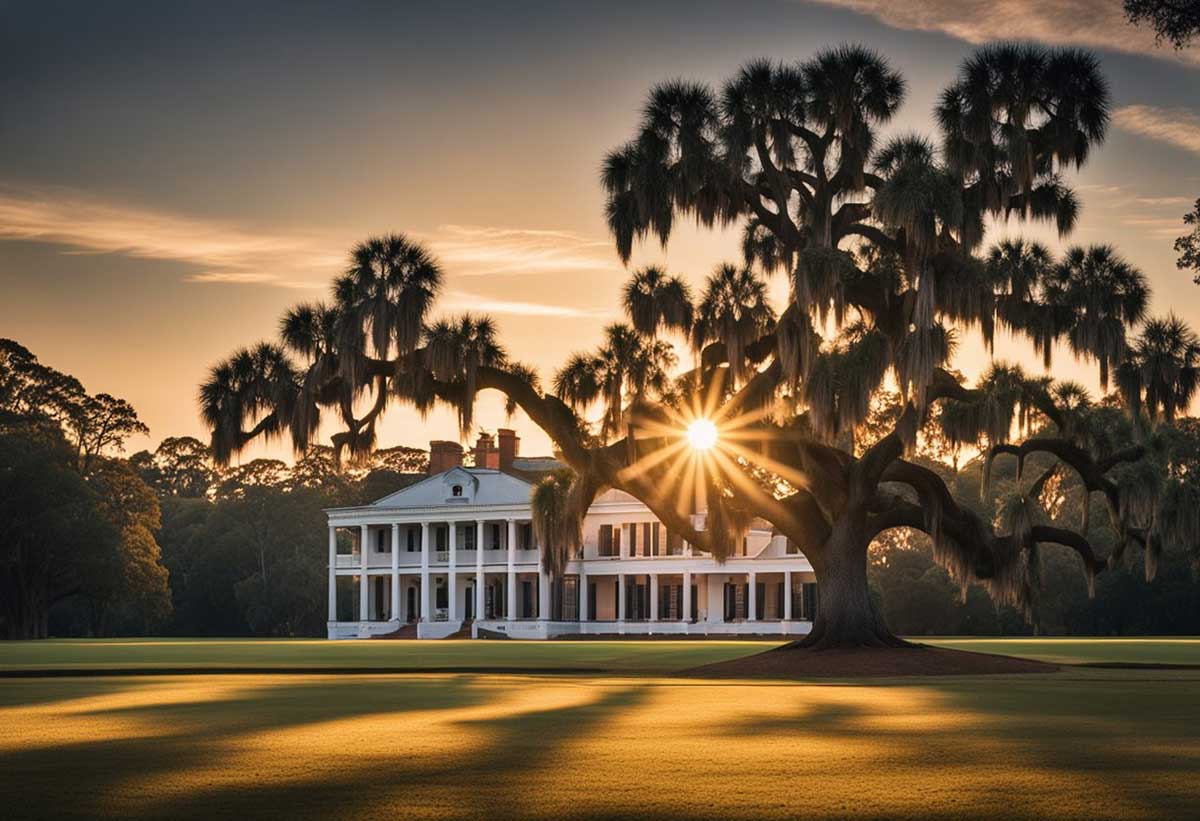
0, 188, 341, 288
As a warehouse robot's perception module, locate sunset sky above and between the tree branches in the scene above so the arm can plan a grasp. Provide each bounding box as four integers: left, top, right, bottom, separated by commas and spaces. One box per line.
0, 0, 1200, 459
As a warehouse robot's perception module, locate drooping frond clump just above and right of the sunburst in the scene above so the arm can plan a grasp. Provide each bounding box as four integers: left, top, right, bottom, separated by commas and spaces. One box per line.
691, 263, 775, 384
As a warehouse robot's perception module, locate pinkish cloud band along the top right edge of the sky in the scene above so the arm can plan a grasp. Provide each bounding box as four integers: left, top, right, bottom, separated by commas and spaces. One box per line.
811, 0, 1200, 67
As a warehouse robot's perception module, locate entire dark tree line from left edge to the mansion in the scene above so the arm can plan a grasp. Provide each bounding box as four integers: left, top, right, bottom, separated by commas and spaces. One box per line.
0, 340, 427, 639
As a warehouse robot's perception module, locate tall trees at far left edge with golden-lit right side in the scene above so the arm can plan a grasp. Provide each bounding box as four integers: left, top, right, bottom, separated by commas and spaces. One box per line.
0, 340, 170, 639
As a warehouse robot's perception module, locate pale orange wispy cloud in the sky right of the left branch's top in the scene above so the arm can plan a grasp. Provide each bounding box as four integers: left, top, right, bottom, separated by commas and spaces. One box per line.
430, 224, 618, 276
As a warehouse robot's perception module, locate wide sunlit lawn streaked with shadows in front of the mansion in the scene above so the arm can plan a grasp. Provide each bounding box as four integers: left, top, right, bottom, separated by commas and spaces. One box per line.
0, 640, 1200, 819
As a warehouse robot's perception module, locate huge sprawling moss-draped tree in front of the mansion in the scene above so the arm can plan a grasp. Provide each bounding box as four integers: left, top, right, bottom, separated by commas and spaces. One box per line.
202, 43, 1200, 647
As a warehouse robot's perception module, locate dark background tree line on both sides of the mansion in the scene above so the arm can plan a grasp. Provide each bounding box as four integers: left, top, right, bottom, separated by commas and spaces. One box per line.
0, 340, 1200, 639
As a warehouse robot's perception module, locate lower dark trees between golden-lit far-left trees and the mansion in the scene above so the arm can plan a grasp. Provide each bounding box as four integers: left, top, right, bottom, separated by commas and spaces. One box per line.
140, 438, 427, 636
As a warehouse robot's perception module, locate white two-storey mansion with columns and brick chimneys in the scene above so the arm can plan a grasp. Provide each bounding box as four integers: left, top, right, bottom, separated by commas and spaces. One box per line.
326, 429, 816, 639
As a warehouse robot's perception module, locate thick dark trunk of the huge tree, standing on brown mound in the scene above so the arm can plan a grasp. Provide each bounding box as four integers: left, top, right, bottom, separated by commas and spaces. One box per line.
791, 515, 908, 649
